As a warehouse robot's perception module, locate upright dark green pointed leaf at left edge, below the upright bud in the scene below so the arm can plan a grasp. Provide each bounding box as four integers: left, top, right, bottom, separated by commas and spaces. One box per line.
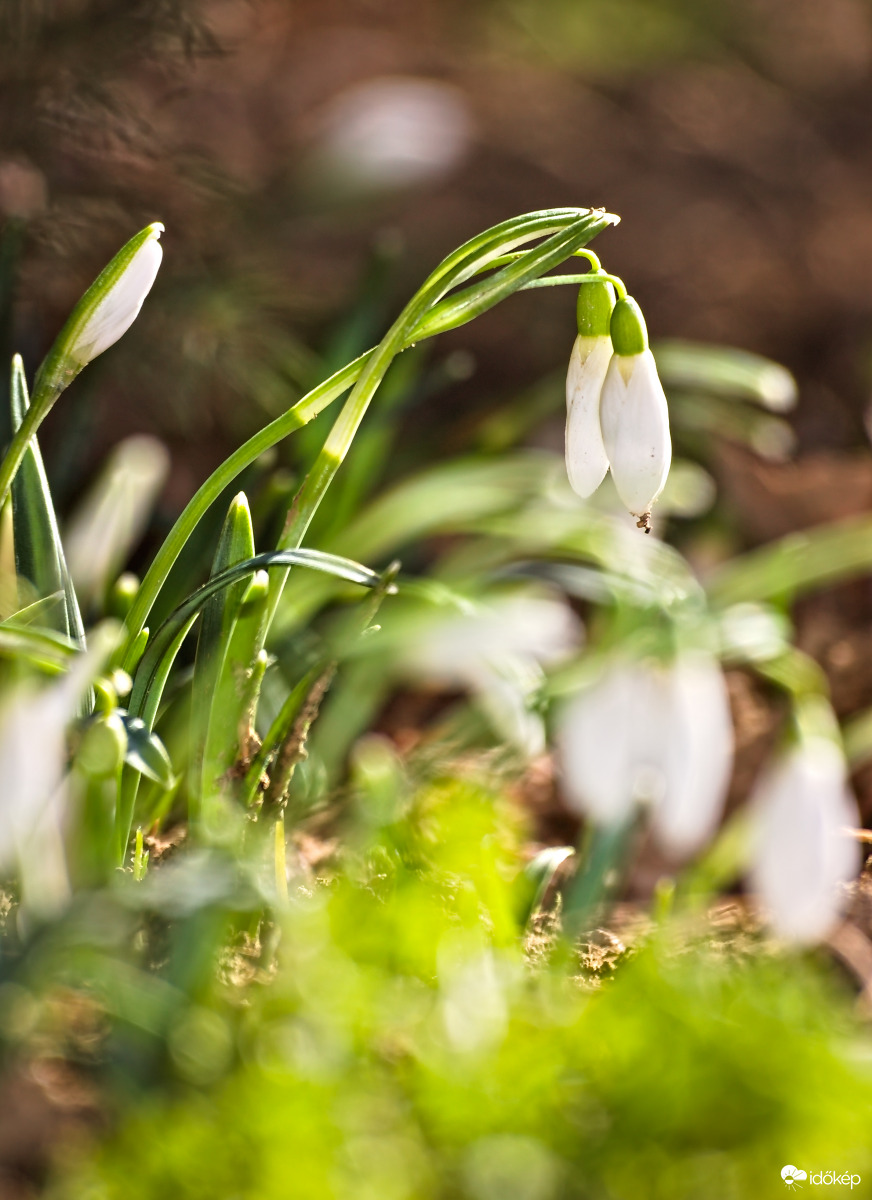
11, 354, 85, 647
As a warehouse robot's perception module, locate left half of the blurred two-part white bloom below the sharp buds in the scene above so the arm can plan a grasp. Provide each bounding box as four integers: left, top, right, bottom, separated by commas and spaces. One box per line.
557, 665, 650, 824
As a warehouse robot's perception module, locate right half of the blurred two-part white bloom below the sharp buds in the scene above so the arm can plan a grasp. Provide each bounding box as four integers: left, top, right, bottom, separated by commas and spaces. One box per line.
653, 654, 733, 858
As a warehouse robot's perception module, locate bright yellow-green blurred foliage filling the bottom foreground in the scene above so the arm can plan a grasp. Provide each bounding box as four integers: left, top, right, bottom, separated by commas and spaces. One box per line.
53, 778, 872, 1200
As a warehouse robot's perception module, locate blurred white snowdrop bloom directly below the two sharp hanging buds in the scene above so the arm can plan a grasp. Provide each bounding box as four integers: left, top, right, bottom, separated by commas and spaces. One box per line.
558, 653, 733, 858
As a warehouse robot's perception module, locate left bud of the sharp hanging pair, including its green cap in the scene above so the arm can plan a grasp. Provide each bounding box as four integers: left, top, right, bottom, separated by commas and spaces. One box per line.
566, 274, 614, 498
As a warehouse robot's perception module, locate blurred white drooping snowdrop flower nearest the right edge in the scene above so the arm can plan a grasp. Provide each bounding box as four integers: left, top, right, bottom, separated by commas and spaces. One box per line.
751, 737, 860, 943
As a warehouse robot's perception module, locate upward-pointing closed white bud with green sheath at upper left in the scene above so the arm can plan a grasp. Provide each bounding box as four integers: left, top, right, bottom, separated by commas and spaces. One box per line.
65, 222, 163, 367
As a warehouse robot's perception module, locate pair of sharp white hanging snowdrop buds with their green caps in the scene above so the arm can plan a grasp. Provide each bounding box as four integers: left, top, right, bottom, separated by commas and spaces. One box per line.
566, 282, 672, 533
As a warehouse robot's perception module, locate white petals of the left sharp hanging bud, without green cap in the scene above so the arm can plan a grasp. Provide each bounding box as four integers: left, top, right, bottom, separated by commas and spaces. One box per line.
566, 334, 612, 499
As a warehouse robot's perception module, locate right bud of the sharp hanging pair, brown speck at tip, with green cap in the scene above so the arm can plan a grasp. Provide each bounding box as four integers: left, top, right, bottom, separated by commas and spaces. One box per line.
600, 296, 672, 532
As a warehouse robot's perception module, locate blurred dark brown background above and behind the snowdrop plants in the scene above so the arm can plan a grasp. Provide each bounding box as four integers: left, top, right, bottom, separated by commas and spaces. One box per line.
0, 0, 872, 541
